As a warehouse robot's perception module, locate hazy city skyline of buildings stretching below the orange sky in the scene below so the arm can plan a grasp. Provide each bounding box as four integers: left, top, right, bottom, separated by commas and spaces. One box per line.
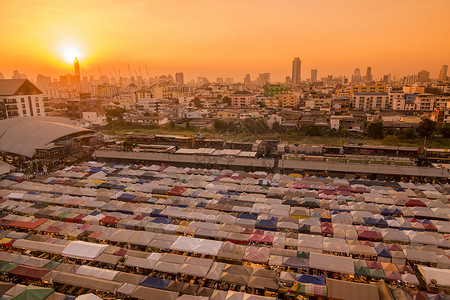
0, 57, 450, 131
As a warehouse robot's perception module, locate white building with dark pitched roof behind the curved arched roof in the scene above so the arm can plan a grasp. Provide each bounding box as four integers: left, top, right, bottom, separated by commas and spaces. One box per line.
0, 79, 50, 119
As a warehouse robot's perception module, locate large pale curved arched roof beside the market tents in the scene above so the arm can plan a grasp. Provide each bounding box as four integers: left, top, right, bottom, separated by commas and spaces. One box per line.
0, 117, 93, 157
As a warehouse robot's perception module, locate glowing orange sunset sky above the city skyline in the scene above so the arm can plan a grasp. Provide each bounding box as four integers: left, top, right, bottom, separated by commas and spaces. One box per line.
0, 0, 450, 81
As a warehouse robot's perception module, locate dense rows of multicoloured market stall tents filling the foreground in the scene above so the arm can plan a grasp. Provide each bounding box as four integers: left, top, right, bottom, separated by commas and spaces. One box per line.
0, 162, 450, 299
